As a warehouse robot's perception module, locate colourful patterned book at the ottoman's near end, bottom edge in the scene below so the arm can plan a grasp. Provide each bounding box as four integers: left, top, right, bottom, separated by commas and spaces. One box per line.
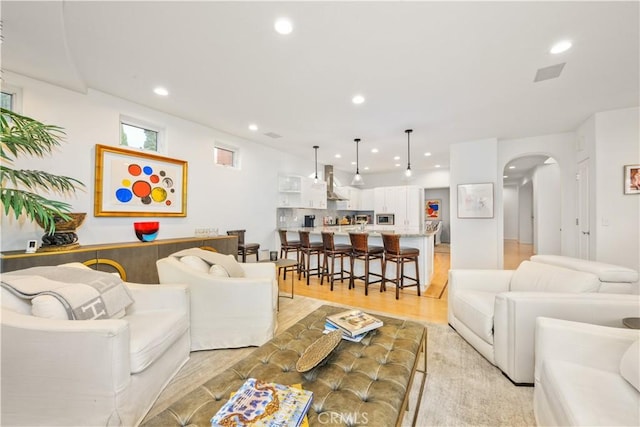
211, 378, 313, 427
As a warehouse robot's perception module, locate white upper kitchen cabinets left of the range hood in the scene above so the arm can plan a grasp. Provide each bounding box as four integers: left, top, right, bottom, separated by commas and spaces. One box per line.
278, 175, 327, 209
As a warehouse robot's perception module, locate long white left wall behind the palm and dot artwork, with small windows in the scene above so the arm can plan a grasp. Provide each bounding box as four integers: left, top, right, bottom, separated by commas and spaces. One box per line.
1, 72, 314, 251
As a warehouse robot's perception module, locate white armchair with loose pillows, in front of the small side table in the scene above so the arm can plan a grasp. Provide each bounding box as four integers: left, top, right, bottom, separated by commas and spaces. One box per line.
156, 249, 278, 351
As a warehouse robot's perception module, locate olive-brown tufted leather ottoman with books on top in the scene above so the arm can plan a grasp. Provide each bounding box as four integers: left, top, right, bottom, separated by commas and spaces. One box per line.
144, 305, 427, 427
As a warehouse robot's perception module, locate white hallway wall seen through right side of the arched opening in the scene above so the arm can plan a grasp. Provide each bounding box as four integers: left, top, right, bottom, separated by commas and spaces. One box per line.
533, 163, 562, 255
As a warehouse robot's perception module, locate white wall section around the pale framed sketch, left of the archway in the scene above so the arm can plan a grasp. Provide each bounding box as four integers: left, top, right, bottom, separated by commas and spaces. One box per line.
449, 138, 504, 268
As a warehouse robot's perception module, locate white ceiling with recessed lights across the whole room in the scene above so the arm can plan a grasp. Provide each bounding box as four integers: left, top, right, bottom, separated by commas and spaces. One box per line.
2, 0, 640, 173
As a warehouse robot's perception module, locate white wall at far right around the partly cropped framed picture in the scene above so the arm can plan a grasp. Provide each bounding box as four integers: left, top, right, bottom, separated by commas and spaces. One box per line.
591, 108, 640, 271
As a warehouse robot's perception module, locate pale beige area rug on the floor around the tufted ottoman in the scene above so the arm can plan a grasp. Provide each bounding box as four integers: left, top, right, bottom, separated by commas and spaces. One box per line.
146, 296, 535, 427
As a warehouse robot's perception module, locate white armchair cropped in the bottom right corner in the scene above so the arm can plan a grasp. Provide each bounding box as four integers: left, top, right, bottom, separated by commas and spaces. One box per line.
533, 317, 640, 426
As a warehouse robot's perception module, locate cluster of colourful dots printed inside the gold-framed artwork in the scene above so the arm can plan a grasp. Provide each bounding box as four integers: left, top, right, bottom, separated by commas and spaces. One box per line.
115, 163, 175, 206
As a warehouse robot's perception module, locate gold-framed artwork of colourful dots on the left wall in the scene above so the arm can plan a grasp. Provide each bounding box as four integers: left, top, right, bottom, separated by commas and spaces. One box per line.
94, 144, 187, 217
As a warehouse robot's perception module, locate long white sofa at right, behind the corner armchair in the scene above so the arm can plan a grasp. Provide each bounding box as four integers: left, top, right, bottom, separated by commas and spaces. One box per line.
448, 261, 640, 384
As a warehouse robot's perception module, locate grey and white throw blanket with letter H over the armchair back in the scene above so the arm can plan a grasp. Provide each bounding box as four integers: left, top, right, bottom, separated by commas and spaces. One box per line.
2, 267, 133, 320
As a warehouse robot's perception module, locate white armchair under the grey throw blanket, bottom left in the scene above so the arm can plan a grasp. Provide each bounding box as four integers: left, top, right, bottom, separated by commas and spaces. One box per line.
1, 270, 189, 426
